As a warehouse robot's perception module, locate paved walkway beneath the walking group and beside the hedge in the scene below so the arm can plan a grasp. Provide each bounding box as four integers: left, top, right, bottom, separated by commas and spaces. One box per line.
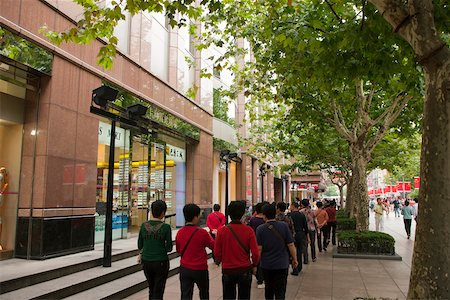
127, 212, 415, 300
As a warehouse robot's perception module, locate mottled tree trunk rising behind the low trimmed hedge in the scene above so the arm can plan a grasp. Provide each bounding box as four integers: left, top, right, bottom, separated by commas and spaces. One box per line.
350, 148, 369, 232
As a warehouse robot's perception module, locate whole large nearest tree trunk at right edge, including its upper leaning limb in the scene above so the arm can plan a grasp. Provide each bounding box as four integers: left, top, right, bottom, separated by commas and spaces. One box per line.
369, 0, 450, 299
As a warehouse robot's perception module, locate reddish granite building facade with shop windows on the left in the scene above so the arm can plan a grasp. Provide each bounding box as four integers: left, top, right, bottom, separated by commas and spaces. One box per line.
0, 0, 288, 259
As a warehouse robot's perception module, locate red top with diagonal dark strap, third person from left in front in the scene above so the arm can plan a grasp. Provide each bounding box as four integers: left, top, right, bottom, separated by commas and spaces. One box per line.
214, 223, 259, 270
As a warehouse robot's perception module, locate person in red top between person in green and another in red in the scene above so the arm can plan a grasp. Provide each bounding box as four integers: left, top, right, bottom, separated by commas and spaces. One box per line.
175, 203, 214, 300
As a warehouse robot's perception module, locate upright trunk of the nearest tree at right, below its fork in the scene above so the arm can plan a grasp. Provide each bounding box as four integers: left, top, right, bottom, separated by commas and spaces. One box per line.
408, 49, 450, 299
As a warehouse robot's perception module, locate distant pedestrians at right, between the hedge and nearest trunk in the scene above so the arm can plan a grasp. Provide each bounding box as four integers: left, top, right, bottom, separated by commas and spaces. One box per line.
370, 196, 418, 239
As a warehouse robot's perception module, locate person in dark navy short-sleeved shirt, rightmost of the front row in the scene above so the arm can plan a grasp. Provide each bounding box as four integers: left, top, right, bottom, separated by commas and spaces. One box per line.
256, 204, 298, 299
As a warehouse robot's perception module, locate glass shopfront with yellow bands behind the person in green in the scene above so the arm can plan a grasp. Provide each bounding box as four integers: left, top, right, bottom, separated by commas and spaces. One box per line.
95, 121, 186, 243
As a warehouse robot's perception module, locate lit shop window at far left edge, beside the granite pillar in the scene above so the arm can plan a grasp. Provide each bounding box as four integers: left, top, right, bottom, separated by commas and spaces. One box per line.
0, 61, 38, 255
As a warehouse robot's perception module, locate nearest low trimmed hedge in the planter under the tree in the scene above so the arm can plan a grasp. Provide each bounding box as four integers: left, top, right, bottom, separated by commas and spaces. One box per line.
337, 230, 395, 255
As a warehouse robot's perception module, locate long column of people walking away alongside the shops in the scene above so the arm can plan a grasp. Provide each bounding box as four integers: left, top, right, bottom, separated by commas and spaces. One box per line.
138, 199, 336, 299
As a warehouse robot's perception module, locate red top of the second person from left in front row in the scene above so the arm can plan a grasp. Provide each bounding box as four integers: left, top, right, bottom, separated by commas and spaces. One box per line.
175, 225, 214, 270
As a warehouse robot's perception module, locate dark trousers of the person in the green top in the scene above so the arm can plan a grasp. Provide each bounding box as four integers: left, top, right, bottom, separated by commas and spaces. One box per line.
142, 260, 169, 299
